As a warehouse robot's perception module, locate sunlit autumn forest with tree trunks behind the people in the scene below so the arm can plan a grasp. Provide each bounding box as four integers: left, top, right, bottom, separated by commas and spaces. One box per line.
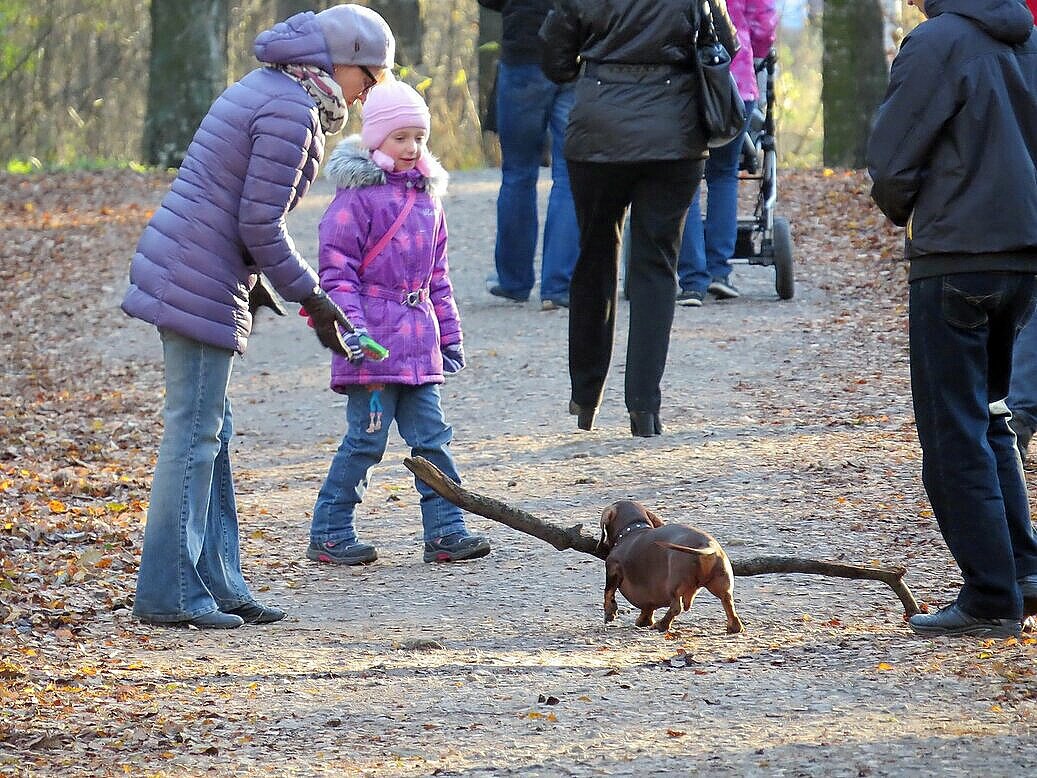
0, 0, 921, 172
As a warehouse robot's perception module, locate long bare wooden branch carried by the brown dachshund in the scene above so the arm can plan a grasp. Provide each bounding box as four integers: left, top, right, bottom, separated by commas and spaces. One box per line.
403, 456, 920, 616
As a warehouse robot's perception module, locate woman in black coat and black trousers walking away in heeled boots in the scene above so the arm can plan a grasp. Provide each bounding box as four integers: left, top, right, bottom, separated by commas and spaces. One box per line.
540, 0, 736, 437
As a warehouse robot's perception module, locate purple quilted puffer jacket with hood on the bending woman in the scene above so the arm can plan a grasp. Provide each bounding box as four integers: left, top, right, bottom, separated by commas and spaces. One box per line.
122, 11, 340, 354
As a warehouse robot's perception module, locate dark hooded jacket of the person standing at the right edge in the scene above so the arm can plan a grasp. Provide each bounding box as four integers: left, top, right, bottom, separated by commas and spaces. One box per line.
868, 0, 1037, 279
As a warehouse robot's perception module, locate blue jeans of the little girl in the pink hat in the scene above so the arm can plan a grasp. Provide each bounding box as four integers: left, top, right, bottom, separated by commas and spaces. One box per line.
310, 384, 466, 545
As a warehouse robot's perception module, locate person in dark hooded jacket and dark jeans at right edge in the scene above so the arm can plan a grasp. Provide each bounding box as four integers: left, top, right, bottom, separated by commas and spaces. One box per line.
868, 0, 1037, 637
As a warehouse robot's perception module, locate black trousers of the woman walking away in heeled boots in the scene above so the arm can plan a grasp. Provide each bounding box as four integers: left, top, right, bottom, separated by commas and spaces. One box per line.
568, 160, 704, 413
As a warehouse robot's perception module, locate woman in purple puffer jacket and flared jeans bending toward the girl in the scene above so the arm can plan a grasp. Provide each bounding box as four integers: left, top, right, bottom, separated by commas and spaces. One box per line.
122, 4, 395, 629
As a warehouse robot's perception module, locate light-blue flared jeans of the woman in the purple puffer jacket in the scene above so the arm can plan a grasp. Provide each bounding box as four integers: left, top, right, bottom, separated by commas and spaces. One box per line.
134, 330, 253, 621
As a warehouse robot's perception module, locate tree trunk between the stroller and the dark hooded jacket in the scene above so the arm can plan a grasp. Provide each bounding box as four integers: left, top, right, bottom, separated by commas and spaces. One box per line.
821, 0, 889, 168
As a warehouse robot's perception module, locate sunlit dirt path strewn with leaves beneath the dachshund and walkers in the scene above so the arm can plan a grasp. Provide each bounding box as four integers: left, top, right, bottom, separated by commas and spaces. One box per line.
10, 170, 1037, 776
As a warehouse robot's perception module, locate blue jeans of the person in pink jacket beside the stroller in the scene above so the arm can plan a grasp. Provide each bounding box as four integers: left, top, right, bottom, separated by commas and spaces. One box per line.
677, 100, 756, 295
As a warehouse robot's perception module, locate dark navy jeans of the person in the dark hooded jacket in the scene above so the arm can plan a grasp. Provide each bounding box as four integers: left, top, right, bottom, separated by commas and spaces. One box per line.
909, 273, 1037, 618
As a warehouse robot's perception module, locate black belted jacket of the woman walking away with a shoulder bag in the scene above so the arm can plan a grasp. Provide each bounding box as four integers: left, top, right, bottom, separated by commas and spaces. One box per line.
540, 0, 721, 162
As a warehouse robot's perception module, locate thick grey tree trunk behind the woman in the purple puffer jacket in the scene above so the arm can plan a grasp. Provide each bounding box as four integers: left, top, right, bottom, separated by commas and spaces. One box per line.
143, 0, 230, 167
